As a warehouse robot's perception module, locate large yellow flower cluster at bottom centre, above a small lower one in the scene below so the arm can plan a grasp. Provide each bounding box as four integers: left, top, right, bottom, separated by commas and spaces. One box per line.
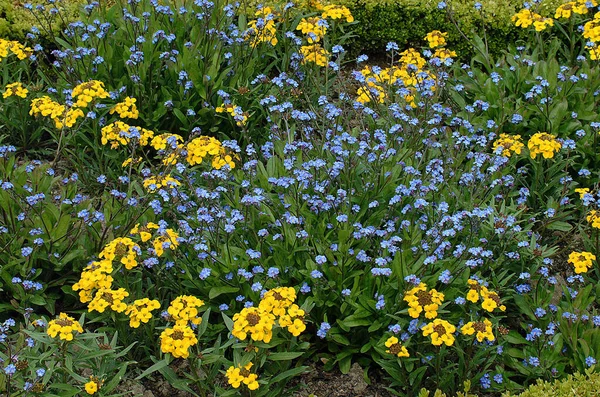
231, 287, 306, 343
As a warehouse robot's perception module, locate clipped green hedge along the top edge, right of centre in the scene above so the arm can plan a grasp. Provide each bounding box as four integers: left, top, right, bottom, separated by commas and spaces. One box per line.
340, 0, 564, 59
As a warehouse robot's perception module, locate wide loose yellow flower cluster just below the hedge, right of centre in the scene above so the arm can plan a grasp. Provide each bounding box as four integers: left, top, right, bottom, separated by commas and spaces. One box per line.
356, 48, 432, 107
